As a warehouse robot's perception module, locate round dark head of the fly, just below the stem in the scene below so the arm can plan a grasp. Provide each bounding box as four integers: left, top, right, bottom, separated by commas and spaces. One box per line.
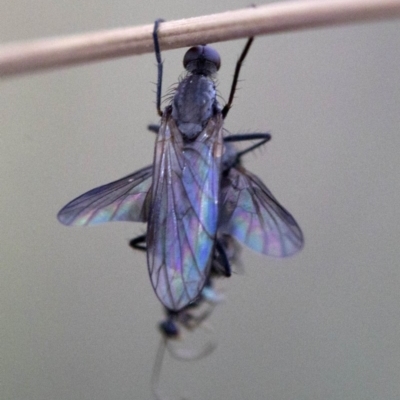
183, 45, 221, 77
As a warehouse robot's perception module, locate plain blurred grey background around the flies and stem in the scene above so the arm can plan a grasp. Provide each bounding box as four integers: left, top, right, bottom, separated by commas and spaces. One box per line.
0, 0, 400, 400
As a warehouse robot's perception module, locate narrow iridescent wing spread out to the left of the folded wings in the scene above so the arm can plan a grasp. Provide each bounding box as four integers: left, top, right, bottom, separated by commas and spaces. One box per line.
57, 166, 153, 226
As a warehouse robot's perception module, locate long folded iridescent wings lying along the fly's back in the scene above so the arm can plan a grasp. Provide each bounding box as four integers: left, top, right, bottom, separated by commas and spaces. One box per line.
147, 113, 223, 311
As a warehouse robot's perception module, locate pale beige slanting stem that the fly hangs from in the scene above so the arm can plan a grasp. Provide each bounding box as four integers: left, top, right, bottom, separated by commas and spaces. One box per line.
0, 0, 400, 76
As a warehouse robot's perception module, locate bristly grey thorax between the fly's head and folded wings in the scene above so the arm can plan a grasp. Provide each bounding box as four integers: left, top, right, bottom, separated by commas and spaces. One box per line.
172, 75, 220, 140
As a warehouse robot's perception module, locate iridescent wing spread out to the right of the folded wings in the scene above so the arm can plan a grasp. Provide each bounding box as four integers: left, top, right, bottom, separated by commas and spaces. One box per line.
219, 168, 304, 257
